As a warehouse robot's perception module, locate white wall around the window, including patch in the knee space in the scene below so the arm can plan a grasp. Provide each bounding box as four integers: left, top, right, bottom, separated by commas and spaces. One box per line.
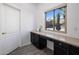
36, 3, 79, 49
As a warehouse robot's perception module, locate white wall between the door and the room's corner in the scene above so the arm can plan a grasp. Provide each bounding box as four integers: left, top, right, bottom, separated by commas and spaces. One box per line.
9, 3, 36, 46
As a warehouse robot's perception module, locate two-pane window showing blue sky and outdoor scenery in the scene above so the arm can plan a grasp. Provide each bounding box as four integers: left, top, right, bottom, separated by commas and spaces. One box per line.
45, 5, 67, 32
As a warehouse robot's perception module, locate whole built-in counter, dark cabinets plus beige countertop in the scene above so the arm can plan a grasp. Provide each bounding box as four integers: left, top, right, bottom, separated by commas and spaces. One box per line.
31, 31, 79, 55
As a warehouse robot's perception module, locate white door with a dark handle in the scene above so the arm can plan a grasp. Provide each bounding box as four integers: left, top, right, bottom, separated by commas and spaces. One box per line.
0, 4, 21, 54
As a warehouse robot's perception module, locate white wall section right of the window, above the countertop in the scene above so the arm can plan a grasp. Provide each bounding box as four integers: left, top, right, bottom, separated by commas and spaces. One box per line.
67, 3, 79, 38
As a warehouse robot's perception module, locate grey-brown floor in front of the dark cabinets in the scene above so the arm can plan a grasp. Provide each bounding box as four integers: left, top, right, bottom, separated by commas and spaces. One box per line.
8, 44, 53, 55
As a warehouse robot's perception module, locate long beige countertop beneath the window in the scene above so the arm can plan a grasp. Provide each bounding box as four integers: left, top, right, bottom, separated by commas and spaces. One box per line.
32, 31, 79, 47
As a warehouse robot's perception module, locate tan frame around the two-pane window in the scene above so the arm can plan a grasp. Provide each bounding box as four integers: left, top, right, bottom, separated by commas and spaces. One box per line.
45, 4, 67, 33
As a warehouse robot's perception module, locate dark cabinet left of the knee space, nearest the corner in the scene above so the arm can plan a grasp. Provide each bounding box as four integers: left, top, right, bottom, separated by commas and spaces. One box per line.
31, 32, 47, 49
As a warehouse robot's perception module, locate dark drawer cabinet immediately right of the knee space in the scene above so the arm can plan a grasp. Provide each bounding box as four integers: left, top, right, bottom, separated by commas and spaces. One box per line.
54, 41, 68, 55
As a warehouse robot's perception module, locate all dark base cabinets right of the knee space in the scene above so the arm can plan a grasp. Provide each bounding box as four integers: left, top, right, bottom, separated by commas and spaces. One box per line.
54, 41, 79, 55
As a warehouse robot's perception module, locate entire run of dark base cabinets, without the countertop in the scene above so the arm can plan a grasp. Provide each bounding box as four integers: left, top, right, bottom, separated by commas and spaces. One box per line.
31, 32, 79, 55
